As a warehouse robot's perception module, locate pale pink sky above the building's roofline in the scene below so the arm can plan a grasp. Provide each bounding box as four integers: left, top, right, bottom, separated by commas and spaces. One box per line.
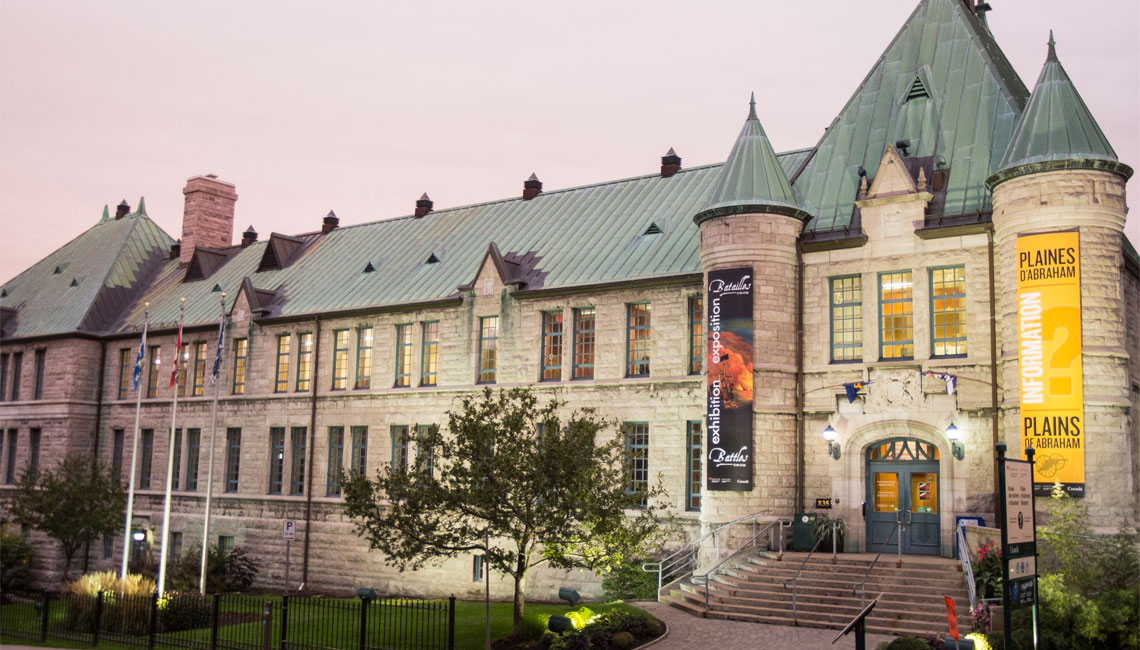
0, 0, 1140, 281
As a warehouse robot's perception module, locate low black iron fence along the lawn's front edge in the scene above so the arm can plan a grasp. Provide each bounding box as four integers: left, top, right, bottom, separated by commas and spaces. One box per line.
0, 592, 455, 650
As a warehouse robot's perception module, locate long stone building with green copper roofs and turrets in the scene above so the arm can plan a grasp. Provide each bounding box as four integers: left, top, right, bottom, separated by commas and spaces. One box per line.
0, 0, 1140, 593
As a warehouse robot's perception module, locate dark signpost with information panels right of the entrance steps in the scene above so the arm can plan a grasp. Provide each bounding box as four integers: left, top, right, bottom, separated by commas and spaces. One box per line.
996, 442, 1037, 648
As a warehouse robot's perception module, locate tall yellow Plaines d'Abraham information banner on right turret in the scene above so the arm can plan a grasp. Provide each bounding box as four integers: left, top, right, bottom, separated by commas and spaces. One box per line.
1017, 231, 1084, 496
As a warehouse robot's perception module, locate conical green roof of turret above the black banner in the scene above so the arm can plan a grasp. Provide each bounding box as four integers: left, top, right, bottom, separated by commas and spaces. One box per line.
694, 94, 808, 224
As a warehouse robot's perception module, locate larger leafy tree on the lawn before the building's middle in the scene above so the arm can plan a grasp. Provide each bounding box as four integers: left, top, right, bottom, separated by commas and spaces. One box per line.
342, 388, 663, 632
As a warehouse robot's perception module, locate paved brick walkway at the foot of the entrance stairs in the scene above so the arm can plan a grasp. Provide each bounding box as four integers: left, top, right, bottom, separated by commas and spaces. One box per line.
633, 601, 894, 650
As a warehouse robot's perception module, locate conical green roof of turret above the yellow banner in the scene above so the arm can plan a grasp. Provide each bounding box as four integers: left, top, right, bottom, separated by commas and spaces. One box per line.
987, 31, 1132, 186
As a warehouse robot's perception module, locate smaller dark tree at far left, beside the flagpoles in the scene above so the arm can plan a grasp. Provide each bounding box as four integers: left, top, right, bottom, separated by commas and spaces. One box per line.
9, 455, 127, 582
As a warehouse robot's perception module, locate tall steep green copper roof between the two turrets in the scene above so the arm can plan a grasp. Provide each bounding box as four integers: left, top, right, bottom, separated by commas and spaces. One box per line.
793, 0, 1029, 230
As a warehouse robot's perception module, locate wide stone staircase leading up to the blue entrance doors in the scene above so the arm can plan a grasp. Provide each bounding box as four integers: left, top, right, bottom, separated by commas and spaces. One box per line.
661, 552, 970, 637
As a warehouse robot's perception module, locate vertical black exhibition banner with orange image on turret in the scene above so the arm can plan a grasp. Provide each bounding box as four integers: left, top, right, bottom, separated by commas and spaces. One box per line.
705, 267, 754, 491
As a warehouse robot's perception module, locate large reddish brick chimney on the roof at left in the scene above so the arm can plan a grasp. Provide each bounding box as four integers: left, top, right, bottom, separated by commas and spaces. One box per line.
178, 173, 237, 265
